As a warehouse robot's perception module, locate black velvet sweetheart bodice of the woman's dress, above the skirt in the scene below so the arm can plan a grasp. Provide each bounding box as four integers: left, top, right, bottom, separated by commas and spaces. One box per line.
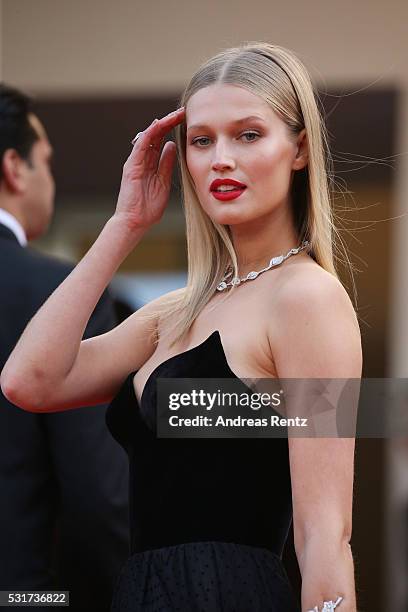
106, 331, 292, 557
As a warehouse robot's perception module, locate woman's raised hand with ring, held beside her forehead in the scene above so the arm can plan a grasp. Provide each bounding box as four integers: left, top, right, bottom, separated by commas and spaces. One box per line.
114, 107, 185, 230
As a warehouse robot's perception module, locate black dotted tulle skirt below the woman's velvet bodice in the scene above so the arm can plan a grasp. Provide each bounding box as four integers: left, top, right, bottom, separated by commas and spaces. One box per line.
111, 542, 300, 612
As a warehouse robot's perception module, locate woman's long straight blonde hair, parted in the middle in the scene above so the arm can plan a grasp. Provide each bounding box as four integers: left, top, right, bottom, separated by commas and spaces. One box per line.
146, 42, 337, 346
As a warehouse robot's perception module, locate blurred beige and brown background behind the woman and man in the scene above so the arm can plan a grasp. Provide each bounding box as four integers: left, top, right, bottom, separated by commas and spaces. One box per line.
0, 0, 408, 612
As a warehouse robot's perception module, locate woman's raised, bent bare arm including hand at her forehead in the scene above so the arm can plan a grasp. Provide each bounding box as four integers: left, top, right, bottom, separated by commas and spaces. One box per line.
0, 109, 184, 411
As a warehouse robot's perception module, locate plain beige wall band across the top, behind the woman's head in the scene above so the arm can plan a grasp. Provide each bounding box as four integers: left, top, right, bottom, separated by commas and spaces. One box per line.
3, 0, 408, 95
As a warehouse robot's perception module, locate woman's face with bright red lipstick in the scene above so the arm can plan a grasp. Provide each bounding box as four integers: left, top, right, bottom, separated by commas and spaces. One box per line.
186, 84, 307, 225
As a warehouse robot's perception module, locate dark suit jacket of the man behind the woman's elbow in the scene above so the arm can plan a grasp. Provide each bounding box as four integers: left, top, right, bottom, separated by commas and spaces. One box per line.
0, 224, 129, 612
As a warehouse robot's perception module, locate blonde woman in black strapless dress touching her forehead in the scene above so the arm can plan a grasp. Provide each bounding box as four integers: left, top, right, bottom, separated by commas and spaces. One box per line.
1, 43, 361, 612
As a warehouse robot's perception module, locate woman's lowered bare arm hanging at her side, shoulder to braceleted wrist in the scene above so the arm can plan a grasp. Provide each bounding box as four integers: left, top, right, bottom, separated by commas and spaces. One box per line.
270, 267, 362, 612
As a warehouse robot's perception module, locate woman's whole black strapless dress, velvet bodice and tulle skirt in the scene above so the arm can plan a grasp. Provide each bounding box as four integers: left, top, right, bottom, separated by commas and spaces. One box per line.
106, 331, 300, 612
